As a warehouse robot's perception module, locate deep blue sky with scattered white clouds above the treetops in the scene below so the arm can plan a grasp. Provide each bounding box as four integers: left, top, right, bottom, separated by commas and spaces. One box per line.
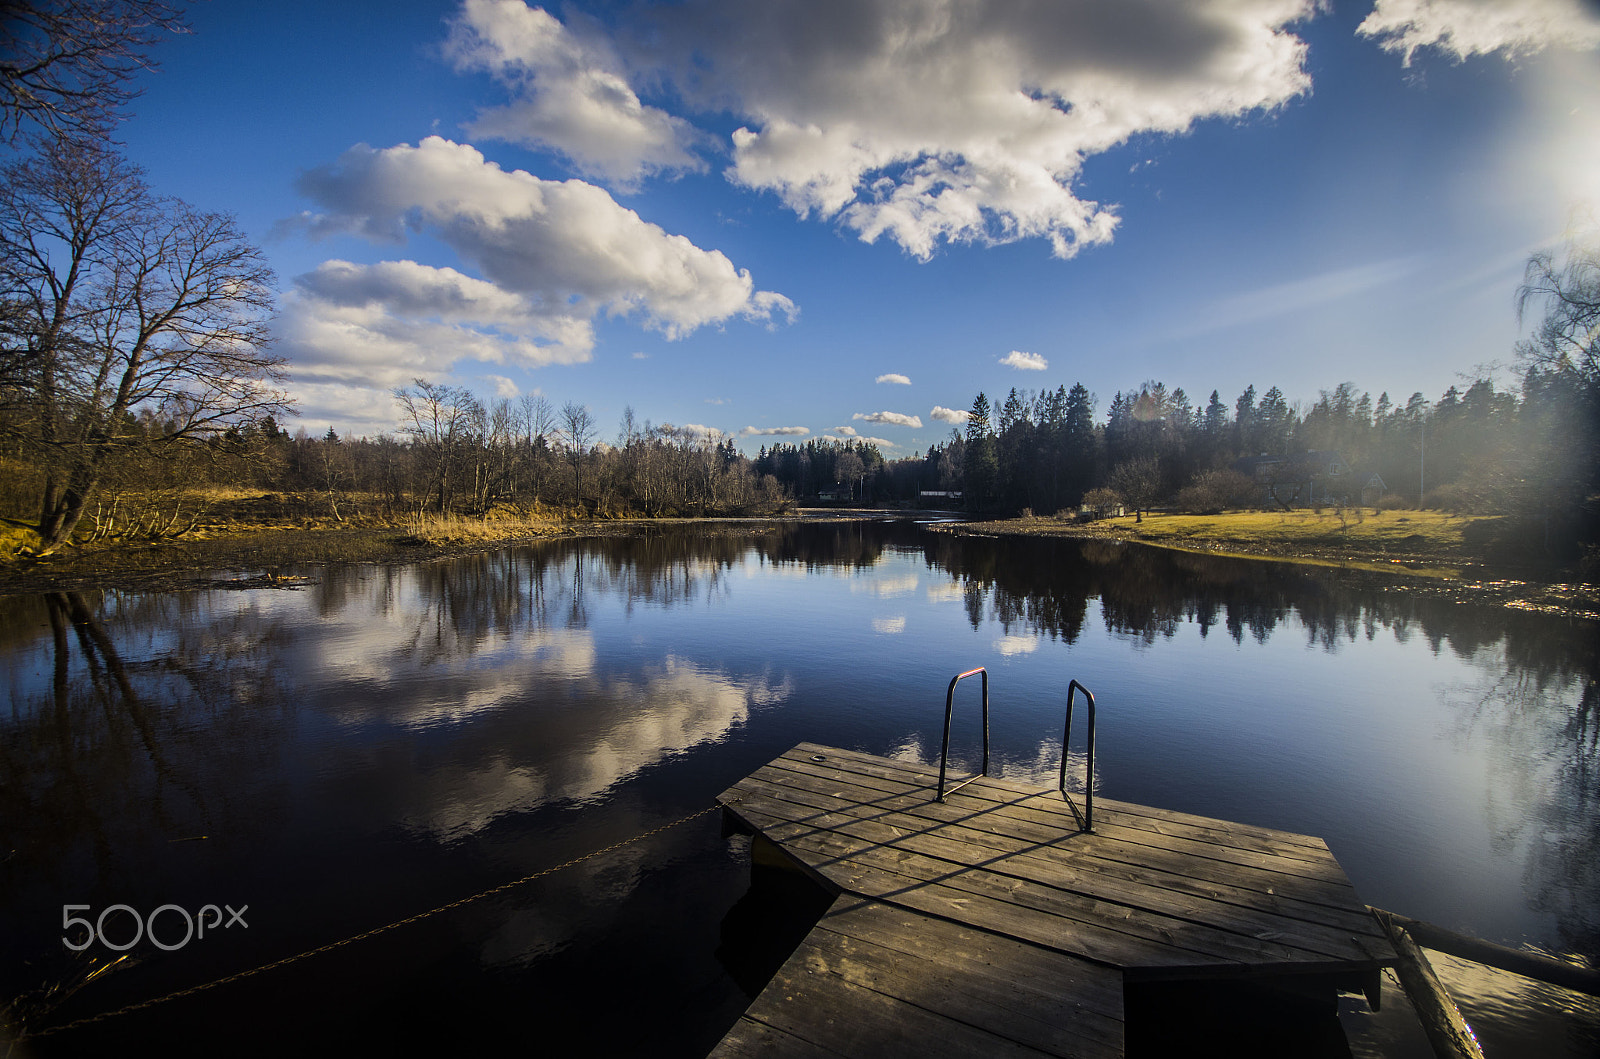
120, 0, 1600, 458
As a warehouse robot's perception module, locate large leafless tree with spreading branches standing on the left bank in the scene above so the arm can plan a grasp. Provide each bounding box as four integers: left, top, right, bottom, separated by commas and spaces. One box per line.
0, 138, 290, 553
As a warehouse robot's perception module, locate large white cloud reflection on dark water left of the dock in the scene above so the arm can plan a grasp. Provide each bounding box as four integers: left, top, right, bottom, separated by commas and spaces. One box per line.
268, 553, 789, 840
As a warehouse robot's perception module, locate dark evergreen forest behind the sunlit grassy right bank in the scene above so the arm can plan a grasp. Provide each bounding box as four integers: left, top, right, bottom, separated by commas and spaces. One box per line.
918, 366, 1597, 514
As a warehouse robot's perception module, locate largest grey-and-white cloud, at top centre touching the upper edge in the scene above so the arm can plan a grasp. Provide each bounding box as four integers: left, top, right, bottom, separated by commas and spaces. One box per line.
635, 0, 1318, 258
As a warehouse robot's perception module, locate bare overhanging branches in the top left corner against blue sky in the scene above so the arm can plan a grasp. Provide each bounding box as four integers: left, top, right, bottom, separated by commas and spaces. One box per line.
0, 0, 189, 142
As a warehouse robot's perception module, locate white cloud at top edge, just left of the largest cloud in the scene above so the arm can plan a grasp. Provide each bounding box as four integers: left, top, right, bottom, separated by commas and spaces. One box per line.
445, 0, 706, 186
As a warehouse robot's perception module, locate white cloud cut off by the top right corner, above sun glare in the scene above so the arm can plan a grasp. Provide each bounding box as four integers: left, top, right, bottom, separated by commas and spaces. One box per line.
1355, 0, 1600, 66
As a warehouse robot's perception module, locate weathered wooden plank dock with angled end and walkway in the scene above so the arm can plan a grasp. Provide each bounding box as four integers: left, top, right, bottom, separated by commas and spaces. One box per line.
712, 744, 1398, 1059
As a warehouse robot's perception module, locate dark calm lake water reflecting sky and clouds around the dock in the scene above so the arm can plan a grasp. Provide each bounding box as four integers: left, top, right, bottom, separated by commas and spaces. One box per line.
0, 522, 1600, 1056
